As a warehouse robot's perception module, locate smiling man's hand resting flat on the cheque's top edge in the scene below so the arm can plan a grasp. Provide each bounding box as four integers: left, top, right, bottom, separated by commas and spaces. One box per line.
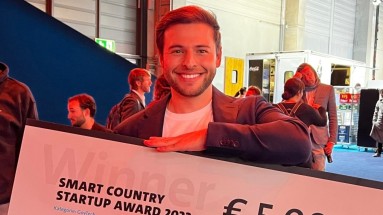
144, 129, 207, 152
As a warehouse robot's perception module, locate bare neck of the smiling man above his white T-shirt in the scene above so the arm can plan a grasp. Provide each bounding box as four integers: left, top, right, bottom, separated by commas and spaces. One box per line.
167, 85, 213, 113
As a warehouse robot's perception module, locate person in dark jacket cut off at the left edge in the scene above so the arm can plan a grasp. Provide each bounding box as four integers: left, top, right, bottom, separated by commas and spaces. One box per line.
0, 62, 38, 215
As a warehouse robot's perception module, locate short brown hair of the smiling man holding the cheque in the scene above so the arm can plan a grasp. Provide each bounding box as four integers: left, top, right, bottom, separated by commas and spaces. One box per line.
156, 5, 221, 55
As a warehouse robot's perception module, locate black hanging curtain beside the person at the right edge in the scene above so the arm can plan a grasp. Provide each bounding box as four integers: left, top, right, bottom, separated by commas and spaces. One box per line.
357, 89, 379, 147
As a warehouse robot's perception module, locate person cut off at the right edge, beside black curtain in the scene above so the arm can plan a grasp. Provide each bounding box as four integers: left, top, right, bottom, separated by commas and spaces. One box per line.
370, 89, 383, 157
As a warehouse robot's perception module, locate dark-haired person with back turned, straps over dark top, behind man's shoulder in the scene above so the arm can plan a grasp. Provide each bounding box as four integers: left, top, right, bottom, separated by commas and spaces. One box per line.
276, 78, 327, 170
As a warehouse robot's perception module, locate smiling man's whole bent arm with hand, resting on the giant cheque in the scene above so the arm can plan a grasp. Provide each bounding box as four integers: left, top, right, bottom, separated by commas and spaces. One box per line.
144, 98, 311, 165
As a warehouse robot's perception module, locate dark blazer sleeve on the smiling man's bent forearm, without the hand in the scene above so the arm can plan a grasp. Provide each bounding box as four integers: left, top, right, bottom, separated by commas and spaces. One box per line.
206, 114, 311, 165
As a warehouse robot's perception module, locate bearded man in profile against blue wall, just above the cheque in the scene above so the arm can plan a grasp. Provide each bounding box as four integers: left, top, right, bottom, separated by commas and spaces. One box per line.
68, 93, 111, 132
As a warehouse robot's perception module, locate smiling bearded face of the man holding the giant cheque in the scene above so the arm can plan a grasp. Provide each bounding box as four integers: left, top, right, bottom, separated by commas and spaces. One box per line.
161, 23, 221, 97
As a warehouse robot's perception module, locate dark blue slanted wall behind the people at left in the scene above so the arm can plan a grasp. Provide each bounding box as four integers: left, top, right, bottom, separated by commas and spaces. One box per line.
0, 0, 152, 125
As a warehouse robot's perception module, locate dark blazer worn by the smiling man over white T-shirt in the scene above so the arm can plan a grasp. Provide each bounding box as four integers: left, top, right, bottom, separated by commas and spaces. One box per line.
114, 87, 311, 165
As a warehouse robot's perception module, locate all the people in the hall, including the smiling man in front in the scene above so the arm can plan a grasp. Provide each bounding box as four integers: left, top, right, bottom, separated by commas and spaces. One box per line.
0, 6, 383, 215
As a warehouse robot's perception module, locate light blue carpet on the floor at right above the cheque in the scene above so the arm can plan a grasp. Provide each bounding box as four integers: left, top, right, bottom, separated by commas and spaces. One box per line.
326, 145, 383, 182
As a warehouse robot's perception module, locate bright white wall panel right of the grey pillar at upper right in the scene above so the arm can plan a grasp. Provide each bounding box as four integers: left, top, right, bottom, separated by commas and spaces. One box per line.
303, 0, 356, 59
